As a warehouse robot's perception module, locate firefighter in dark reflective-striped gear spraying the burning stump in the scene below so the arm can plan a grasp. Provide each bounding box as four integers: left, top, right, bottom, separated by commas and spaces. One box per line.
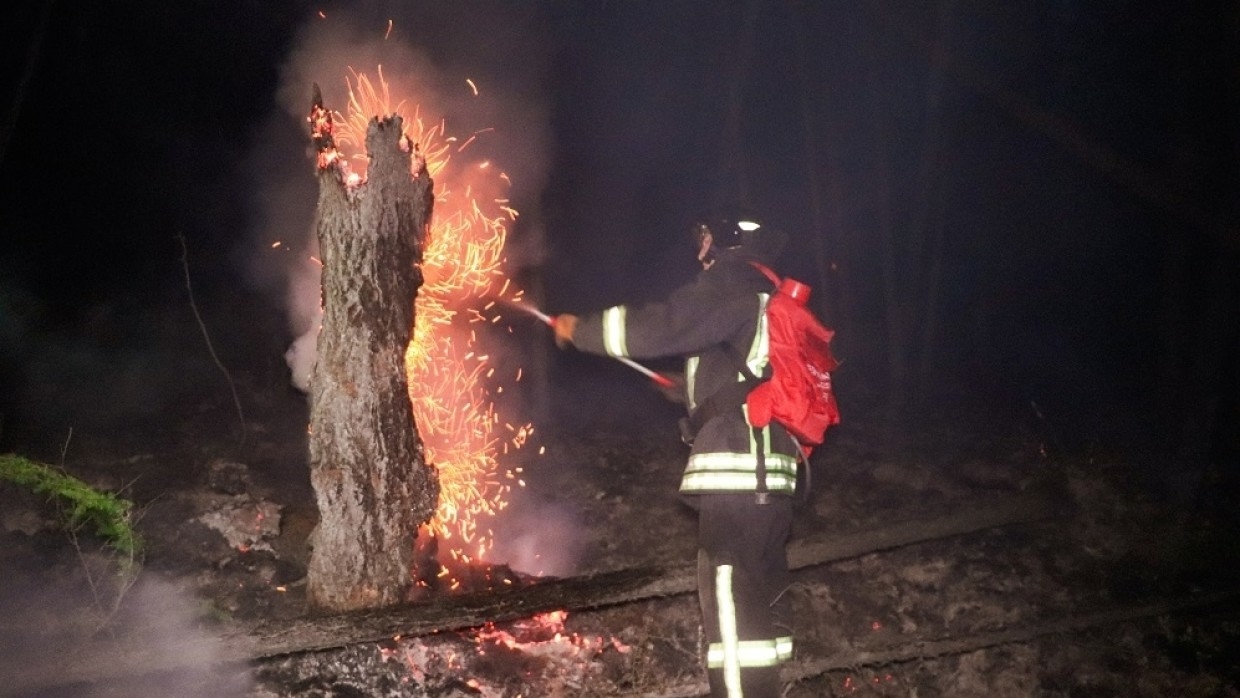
554, 217, 799, 698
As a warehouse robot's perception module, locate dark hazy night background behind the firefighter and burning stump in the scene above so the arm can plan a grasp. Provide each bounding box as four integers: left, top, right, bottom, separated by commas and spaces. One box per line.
0, 0, 1240, 463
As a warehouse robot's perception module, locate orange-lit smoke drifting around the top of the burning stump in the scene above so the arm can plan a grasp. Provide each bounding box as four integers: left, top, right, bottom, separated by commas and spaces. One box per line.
246, 2, 548, 391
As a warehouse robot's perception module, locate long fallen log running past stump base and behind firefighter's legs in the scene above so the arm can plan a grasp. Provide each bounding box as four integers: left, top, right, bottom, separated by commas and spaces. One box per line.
0, 495, 1055, 692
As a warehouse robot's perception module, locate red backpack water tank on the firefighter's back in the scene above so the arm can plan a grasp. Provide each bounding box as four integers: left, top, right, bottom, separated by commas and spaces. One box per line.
745, 262, 839, 457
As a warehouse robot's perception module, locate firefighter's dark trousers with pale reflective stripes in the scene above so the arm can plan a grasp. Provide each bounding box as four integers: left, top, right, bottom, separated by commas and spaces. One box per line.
696, 492, 792, 698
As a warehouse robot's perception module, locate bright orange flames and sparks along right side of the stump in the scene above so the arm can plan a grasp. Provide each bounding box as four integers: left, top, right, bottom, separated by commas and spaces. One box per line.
326, 68, 533, 589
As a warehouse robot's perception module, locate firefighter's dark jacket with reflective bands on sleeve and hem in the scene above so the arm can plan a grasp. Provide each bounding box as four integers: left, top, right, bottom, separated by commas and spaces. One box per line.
573, 247, 797, 495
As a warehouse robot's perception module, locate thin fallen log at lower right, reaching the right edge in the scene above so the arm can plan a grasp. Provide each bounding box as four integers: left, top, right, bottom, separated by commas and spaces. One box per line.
616, 589, 1240, 698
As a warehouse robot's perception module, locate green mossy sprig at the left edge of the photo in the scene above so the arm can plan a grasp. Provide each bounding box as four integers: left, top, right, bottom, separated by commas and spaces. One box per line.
0, 454, 143, 558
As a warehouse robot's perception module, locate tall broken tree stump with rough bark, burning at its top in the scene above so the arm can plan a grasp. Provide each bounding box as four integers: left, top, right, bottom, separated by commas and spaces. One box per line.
306, 86, 439, 611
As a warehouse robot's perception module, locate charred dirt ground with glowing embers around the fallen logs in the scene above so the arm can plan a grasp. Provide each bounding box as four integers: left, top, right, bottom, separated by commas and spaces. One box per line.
0, 308, 1240, 698
